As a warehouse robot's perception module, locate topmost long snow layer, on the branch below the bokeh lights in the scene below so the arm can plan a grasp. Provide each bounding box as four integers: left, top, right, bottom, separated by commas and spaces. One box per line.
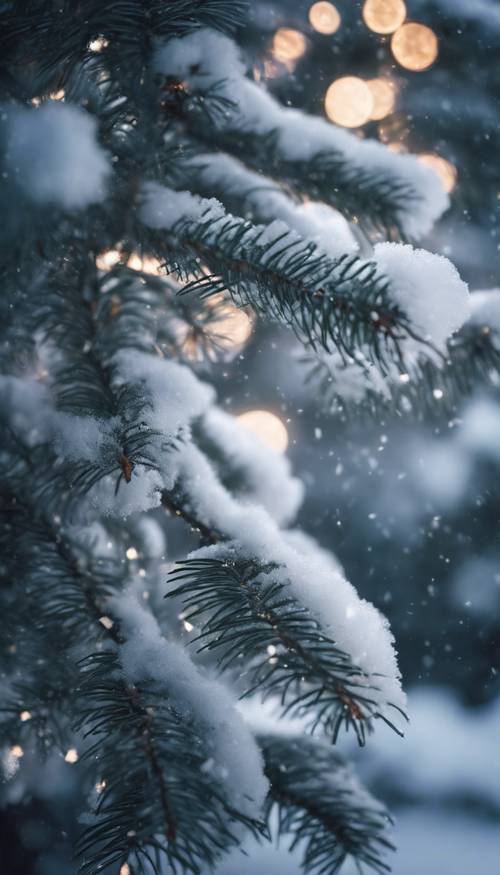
154, 29, 449, 237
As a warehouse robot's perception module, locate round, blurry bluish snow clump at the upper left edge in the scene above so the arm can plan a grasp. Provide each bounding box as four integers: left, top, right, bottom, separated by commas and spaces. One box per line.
7, 101, 111, 209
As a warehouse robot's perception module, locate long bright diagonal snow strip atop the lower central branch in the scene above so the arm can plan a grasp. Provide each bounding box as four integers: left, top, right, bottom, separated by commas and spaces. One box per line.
170, 445, 405, 720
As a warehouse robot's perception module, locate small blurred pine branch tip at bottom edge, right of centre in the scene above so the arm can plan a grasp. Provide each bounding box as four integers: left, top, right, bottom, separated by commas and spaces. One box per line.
259, 735, 394, 875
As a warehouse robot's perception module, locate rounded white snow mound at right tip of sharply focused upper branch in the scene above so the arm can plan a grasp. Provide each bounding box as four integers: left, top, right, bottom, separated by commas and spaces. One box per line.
375, 243, 470, 349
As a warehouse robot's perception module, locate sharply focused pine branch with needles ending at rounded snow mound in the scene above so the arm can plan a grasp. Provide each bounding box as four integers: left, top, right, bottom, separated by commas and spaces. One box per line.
144, 204, 423, 369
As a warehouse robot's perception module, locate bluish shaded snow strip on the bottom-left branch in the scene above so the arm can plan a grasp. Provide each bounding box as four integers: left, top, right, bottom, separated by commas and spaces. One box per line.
113, 590, 268, 817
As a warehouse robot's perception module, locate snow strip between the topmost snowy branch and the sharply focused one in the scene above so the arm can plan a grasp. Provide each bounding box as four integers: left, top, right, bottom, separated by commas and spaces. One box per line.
192, 152, 358, 258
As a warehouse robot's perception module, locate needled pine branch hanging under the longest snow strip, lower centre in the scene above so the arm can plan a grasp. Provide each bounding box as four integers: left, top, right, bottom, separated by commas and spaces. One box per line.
167, 558, 404, 745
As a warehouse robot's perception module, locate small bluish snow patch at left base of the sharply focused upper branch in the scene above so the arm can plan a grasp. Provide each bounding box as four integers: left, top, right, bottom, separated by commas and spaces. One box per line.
139, 182, 225, 230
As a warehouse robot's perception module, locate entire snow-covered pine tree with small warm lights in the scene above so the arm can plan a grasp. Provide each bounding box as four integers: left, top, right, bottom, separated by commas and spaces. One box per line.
0, 0, 496, 875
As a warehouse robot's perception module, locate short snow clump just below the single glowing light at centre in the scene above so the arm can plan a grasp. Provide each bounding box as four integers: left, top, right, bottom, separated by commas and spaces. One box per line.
201, 408, 304, 525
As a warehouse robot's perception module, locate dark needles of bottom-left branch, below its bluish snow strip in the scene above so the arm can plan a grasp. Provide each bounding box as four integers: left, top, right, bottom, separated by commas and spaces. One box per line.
76, 653, 262, 875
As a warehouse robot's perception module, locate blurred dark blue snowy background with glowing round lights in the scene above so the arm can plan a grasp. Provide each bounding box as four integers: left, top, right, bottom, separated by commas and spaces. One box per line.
0, 0, 500, 875
